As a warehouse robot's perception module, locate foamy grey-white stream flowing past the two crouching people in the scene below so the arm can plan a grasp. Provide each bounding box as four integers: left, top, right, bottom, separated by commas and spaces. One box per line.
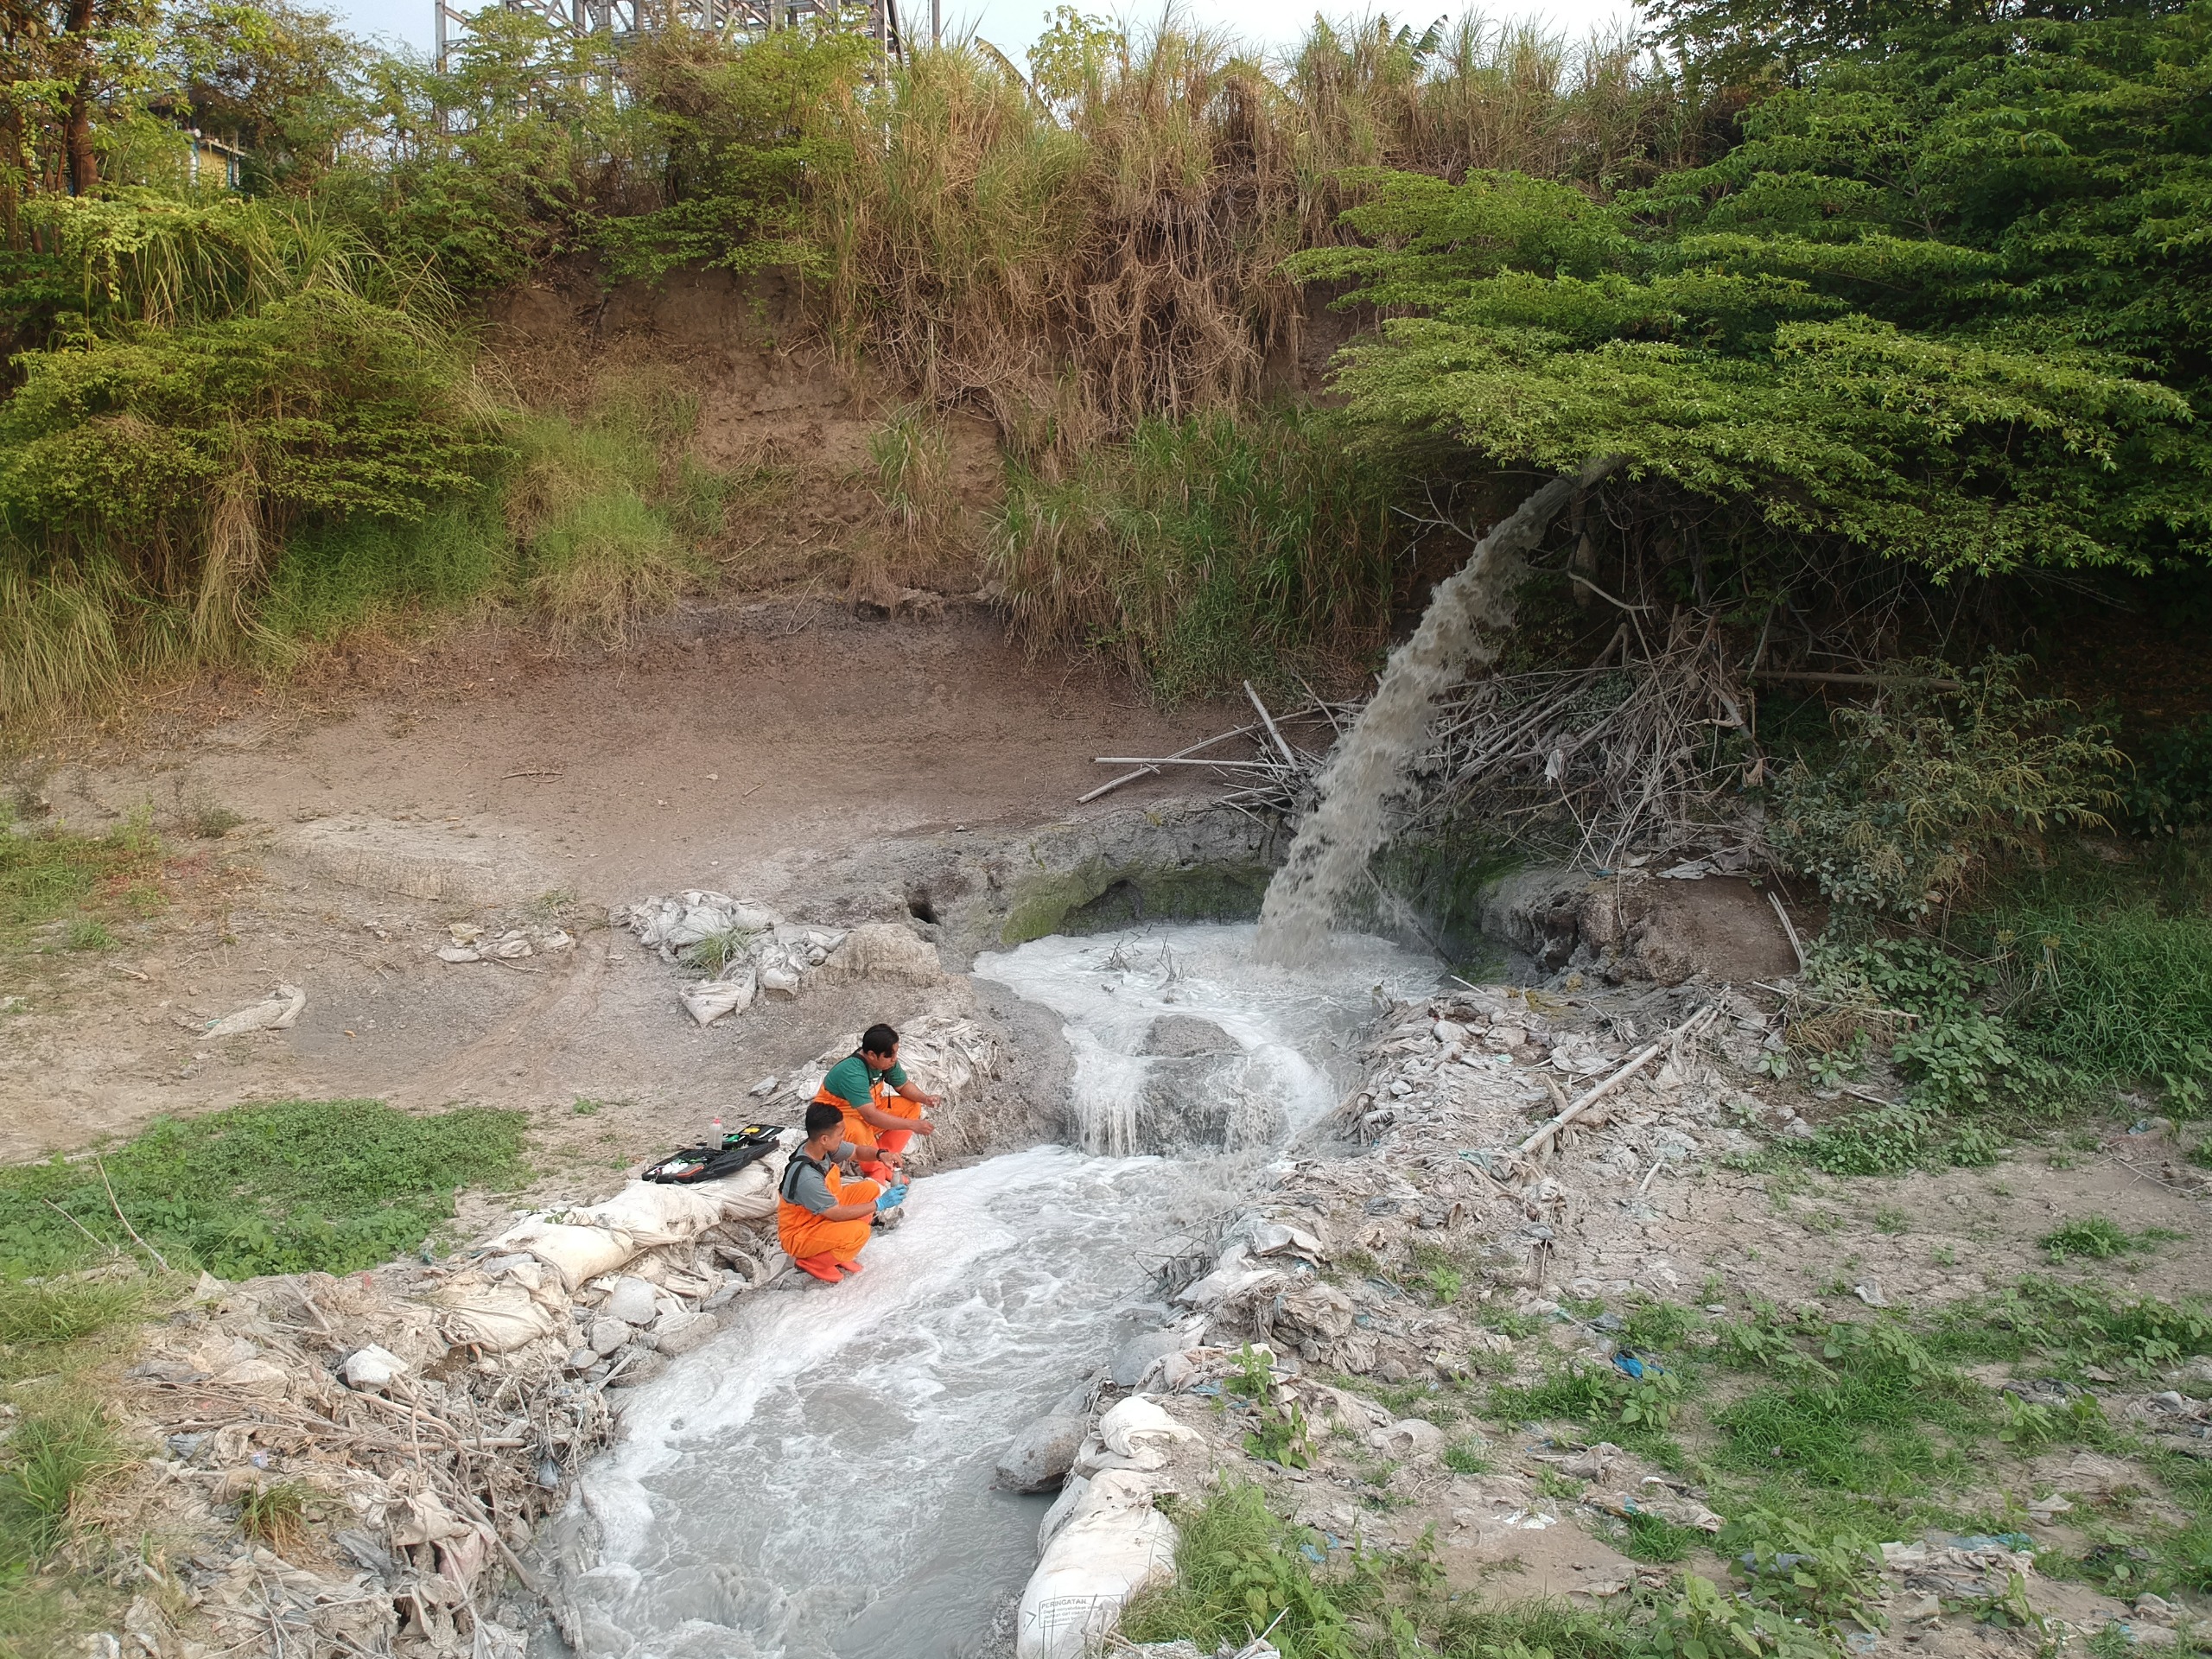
569, 927, 1435, 1659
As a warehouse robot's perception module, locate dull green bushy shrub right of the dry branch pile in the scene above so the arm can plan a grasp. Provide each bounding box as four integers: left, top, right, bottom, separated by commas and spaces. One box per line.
1767, 657, 2121, 920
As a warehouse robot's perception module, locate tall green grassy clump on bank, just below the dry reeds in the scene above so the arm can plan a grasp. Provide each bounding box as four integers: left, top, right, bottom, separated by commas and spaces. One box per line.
991, 410, 1394, 699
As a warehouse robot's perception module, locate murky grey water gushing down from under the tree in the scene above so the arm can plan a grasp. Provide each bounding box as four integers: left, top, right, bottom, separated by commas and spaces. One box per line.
1256, 455, 1621, 964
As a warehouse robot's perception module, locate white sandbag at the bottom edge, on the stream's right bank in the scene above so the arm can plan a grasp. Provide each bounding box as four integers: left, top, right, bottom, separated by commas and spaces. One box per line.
1015, 1469, 1174, 1659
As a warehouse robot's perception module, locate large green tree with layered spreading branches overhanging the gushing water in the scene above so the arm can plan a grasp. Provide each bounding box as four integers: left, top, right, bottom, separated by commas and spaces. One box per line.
1296, 0, 2212, 577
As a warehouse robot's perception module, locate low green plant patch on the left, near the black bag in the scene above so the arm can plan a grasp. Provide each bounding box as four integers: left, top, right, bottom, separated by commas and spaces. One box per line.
0, 1099, 526, 1279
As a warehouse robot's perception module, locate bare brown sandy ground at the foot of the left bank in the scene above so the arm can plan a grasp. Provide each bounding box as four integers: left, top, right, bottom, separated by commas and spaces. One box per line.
0, 604, 1232, 1179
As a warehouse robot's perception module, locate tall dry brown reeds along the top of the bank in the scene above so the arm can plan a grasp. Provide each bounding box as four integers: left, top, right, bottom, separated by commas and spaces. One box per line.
814, 17, 1679, 467
